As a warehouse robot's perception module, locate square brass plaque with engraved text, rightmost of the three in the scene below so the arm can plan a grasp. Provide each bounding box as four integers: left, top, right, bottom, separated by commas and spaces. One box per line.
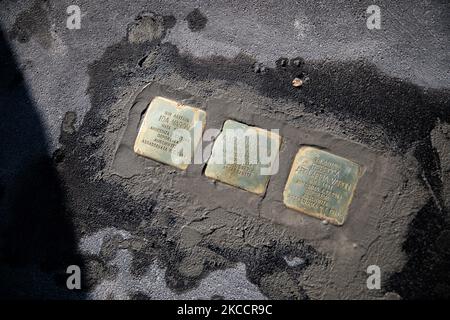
283, 147, 361, 225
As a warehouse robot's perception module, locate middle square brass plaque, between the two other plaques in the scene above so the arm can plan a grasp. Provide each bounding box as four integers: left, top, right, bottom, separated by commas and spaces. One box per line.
205, 120, 281, 194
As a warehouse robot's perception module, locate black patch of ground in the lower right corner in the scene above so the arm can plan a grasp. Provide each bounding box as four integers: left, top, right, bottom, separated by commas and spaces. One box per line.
387, 139, 450, 299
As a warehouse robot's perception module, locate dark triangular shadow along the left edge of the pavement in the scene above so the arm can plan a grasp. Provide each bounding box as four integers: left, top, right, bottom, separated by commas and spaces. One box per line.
0, 28, 84, 299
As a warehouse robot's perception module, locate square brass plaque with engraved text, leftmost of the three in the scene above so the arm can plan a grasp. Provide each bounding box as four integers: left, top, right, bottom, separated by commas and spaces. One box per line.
134, 97, 206, 170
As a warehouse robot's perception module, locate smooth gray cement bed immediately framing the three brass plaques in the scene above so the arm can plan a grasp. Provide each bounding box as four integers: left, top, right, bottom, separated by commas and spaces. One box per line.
113, 83, 393, 235
